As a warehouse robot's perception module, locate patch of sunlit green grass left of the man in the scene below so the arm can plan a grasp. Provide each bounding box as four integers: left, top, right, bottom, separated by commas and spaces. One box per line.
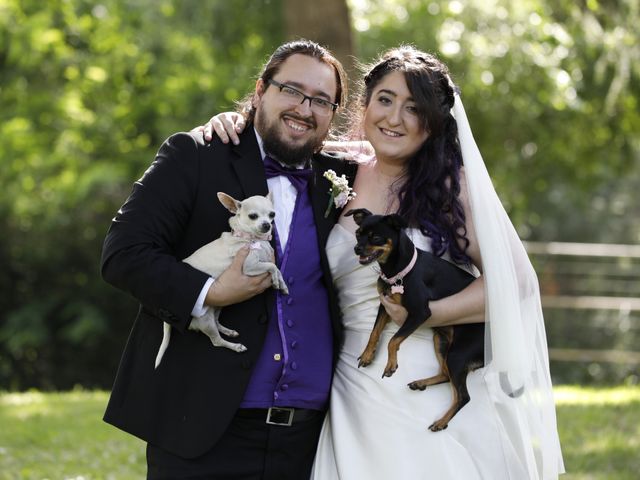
0, 391, 146, 480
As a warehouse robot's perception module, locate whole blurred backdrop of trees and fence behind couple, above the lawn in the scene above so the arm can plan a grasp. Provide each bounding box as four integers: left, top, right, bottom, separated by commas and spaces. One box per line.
0, 0, 640, 391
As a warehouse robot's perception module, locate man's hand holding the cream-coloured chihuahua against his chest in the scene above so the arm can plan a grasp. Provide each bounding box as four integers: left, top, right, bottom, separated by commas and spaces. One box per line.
204, 247, 271, 307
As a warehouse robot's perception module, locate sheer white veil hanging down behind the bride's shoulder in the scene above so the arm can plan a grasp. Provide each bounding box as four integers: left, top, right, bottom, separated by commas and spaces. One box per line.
452, 94, 564, 480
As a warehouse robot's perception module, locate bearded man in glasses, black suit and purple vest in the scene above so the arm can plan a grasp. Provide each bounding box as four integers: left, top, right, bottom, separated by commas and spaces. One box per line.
102, 40, 353, 480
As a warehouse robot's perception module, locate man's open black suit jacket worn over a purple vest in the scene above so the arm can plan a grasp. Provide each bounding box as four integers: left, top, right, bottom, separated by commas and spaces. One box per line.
102, 126, 355, 458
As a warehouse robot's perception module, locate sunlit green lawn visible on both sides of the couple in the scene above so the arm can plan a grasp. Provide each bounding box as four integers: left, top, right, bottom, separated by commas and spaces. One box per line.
0, 387, 640, 480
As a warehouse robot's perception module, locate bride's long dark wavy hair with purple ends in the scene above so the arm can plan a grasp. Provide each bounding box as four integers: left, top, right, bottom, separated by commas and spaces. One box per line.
351, 45, 470, 263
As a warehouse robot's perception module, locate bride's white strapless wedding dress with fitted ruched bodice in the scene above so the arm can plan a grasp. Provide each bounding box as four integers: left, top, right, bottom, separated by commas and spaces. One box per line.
311, 224, 527, 480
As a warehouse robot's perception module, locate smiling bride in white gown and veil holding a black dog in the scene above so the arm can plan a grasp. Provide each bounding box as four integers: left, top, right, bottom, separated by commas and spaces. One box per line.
311, 47, 564, 480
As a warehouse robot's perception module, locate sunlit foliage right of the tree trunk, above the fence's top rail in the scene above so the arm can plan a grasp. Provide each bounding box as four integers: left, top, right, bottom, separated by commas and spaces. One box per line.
352, 0, 640, 243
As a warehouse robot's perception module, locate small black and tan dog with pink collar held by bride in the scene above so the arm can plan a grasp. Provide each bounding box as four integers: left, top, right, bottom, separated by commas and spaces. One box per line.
345, 208, 484, 432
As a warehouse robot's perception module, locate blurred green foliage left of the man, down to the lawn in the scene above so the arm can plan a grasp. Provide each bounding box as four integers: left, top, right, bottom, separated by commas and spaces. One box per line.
0, 0, 282, 388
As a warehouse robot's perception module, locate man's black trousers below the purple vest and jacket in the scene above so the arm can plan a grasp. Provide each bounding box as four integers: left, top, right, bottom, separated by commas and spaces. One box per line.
147, 412, 324, 480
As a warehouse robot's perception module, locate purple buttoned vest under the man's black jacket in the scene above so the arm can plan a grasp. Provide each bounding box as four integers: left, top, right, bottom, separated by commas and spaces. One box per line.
240, 188, 333, 410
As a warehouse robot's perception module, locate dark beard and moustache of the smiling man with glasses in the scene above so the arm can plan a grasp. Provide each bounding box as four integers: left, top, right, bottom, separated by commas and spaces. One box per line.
255, 111, 323, 166
